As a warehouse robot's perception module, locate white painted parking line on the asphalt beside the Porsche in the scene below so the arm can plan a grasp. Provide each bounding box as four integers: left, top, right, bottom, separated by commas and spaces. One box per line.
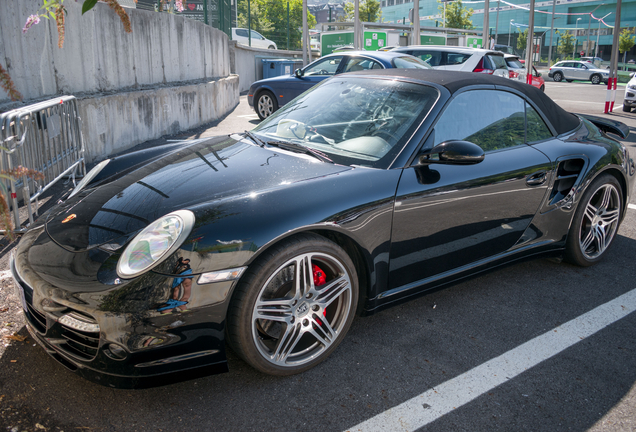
347, 289, 636, 432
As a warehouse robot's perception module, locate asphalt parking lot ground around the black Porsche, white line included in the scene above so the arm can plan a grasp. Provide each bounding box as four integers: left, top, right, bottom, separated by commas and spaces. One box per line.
0, 82, 636, 432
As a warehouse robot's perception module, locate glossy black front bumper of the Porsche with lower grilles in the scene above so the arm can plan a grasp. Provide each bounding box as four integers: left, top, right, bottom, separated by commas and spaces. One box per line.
10, 240, 228, 388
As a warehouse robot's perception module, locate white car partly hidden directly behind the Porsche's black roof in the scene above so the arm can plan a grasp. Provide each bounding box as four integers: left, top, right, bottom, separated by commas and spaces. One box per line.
391, 45, 508, 78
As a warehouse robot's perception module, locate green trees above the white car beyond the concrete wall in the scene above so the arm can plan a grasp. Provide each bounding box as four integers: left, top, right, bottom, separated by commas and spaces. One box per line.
237, 0, 316, 49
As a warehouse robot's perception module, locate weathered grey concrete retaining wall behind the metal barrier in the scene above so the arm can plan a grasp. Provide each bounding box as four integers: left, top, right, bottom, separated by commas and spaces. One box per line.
0, 0, 239, 162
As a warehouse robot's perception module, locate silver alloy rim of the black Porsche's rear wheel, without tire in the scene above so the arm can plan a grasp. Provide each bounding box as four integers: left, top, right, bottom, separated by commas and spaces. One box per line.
579, 183, 621, 260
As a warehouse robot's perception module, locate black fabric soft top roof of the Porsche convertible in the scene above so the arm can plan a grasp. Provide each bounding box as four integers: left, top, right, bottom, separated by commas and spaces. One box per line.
347, 69, 581, 135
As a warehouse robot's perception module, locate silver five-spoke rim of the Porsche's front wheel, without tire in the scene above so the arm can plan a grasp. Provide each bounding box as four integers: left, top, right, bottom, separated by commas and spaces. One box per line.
251, 252, 353, 367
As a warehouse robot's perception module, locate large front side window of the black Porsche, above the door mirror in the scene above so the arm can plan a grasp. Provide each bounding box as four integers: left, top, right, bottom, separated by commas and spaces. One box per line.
433, 90, 525, 151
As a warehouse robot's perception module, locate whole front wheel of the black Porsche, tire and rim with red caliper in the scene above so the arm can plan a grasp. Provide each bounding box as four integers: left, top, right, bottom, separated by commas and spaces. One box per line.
227, 234, 358, 376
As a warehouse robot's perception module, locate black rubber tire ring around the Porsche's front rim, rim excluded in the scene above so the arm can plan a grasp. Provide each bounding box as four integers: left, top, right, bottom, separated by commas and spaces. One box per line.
228, 235, 359, 376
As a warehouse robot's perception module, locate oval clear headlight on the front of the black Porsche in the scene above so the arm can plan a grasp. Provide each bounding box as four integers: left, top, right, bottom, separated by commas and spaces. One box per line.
117, 210, 194, 279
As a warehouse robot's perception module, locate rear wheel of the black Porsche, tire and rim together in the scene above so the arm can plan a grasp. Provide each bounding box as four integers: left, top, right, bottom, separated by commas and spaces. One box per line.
565, 174, 623, 267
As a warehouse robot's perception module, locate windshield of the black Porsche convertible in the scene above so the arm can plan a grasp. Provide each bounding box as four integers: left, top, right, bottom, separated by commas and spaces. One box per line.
252, 76, 439, 168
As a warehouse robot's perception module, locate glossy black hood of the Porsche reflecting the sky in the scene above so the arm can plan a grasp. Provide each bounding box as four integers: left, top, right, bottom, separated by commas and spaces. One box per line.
46, 137, 350, 252
